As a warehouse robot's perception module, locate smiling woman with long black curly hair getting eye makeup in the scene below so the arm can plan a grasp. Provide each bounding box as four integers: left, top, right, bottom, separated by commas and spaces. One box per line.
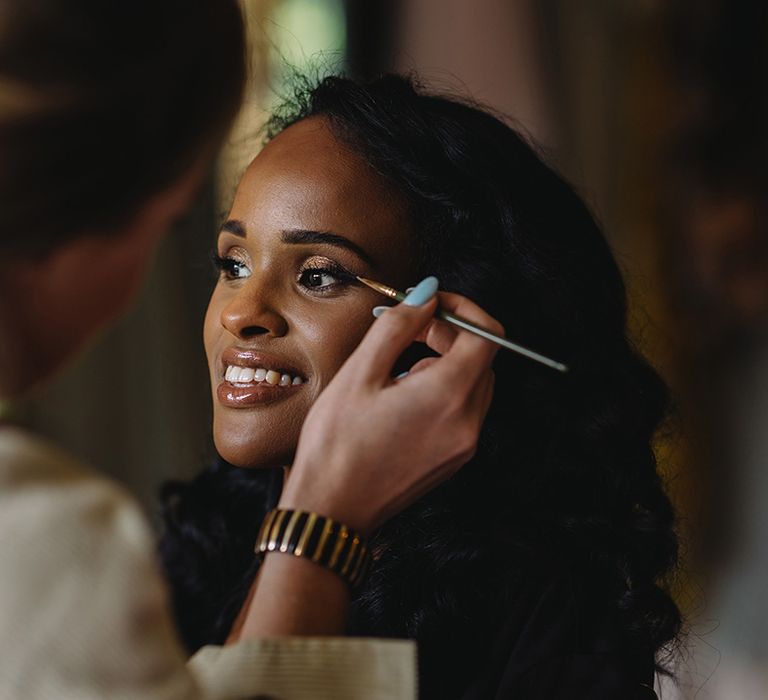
161, 76, 681, 698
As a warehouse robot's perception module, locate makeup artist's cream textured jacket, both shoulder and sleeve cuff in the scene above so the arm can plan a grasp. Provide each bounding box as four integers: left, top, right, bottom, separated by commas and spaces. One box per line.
0, 427, 416, 700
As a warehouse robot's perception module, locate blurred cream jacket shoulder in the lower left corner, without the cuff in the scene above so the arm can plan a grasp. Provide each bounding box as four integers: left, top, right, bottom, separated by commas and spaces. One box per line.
0, 428, 200, 700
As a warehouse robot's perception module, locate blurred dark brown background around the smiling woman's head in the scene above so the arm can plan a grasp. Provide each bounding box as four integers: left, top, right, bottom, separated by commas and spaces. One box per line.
21, 0, 768, 700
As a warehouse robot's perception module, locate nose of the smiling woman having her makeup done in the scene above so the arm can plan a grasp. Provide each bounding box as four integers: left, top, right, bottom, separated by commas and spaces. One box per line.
221, 278, 288, 340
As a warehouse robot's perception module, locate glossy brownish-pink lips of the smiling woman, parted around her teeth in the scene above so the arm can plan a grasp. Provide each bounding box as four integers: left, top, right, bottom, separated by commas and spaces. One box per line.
216, 348, 307, 408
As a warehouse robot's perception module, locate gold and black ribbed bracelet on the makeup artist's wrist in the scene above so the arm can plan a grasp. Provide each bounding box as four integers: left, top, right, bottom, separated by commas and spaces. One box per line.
255, 508, 371, 589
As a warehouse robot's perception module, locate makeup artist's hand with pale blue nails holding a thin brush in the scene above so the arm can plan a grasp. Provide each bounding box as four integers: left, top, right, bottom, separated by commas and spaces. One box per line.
280, 278, 504, 533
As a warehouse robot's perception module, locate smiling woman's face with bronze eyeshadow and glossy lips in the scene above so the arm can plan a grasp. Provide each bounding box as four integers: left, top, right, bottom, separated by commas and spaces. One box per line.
205, 117, 415, 467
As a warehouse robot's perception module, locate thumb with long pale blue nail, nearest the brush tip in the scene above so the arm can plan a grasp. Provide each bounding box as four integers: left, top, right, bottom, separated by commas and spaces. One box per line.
347, 277, 438, 382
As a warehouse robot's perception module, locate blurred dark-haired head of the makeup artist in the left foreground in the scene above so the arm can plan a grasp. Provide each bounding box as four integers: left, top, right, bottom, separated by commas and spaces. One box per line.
0, 0, 245, 394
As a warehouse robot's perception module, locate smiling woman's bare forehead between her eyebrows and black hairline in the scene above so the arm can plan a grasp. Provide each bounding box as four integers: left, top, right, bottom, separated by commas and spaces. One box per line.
230, 117, 413, 268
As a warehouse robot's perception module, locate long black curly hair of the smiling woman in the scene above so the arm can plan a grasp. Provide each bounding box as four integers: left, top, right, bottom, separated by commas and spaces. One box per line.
161, 75, 681, 697
